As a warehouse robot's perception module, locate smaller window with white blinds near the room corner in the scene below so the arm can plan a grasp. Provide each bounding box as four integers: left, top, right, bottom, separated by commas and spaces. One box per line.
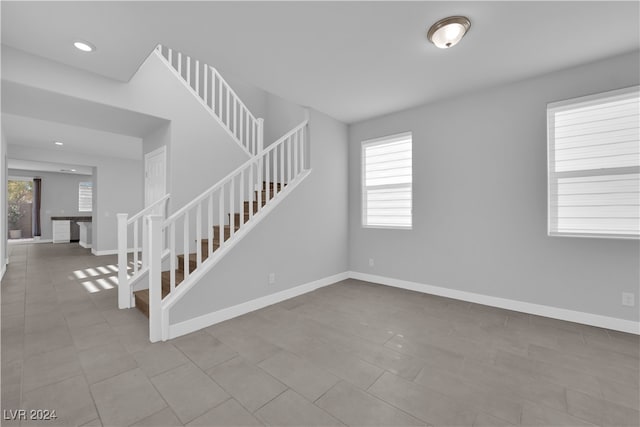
362, 132, 412, 229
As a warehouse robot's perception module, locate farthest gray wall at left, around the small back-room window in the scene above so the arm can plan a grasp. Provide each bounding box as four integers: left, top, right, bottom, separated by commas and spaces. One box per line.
9, 169, 95, 240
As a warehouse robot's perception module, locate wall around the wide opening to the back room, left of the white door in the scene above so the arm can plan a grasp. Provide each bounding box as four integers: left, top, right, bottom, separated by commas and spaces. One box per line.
7, 144, 143, 254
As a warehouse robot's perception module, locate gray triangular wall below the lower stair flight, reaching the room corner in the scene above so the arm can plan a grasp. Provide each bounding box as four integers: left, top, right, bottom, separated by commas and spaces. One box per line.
170, 111, 348, 324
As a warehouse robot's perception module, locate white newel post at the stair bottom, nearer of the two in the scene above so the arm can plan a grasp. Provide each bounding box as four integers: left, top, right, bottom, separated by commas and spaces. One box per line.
145, 215, 163, 342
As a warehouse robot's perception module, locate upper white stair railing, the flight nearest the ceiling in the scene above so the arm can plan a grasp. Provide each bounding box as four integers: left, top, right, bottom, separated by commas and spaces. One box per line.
156, 45, 264, 156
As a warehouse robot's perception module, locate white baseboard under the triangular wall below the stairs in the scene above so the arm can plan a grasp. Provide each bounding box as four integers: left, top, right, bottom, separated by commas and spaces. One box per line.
169, 272, 348, 339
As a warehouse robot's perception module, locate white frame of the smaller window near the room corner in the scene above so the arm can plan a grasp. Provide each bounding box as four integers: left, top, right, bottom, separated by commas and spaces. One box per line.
360, 131, 413, 230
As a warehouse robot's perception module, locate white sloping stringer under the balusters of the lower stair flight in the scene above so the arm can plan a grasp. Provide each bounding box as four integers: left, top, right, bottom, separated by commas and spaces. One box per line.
161, 169, 312, 341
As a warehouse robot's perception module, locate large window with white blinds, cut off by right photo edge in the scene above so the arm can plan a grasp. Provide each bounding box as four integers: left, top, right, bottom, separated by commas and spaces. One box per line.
547, 86, 640, 239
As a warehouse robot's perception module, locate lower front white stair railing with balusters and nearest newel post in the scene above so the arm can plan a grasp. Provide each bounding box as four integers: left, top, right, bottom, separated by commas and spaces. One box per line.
147, 120, 309, 342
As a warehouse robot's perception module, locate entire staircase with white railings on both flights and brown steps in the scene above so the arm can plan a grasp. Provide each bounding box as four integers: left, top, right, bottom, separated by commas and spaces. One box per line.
117, 46, 311, 342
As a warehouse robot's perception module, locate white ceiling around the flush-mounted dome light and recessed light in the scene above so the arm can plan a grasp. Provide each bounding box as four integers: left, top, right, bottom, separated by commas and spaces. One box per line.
1, 1, 640, 123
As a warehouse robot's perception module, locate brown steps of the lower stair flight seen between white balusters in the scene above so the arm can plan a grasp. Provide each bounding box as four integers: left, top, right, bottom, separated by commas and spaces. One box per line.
133, 182, 286, 317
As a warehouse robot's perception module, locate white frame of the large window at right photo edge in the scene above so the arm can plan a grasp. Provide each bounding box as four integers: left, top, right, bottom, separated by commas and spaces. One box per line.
547, 85, 640, 240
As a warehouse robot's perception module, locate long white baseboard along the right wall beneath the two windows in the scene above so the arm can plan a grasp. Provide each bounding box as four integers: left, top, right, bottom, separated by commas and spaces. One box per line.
348, 271, 640, 335
